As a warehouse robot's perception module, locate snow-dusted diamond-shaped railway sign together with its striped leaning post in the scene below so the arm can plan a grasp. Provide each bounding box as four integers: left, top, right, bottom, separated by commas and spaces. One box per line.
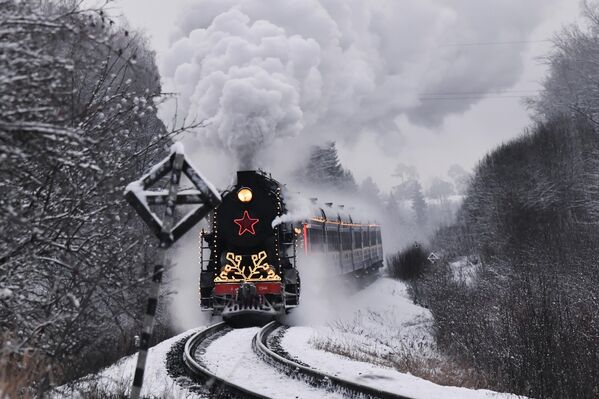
125, 143, 221, 399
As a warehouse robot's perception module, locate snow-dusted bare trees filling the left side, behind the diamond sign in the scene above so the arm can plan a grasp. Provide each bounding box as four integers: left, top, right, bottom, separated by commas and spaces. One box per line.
0, 0, 186, 391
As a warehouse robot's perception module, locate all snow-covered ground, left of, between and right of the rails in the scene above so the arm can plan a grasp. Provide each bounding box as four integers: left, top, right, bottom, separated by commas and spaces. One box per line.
55, 278, 517, 399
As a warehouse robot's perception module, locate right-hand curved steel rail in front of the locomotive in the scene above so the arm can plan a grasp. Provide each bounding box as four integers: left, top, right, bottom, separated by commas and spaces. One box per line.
252, 321, 418, 399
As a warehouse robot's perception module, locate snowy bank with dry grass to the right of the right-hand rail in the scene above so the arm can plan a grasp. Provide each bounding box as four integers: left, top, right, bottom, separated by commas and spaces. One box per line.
281, 278, 518, 399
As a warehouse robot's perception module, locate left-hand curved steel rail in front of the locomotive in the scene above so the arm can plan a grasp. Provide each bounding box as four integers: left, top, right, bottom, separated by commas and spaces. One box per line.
183, 322, 270, 399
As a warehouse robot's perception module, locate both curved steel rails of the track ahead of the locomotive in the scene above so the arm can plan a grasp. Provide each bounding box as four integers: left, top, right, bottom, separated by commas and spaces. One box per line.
183, 321, 411, 399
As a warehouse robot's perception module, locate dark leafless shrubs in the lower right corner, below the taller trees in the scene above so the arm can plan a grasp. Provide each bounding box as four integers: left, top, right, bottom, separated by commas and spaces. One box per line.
410, 263, 599, 398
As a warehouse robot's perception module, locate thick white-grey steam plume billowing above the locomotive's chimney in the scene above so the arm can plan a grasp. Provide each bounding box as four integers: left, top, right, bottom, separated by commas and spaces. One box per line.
162, 0, 549, 170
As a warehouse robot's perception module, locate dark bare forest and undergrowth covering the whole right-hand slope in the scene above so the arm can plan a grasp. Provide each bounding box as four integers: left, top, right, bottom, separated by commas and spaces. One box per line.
389, 6, 599, 398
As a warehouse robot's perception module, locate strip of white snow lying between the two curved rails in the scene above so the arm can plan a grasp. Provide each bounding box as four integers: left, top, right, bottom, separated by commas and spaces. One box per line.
202, 327, 344, 399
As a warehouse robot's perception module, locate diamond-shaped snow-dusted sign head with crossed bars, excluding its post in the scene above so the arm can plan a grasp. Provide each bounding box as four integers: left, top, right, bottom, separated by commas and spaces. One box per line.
125, 143, 221, 247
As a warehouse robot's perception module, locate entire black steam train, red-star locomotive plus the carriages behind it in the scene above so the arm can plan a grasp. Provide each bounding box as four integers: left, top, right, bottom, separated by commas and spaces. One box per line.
199, 171, 383, 323
